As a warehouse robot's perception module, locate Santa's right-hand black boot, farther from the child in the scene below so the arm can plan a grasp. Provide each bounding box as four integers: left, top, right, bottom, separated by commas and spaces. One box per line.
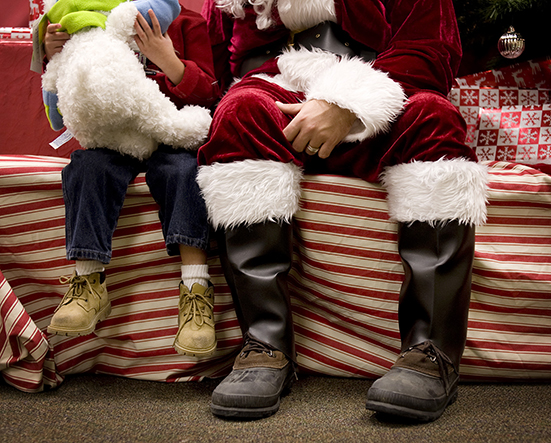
367, 221, 475, 421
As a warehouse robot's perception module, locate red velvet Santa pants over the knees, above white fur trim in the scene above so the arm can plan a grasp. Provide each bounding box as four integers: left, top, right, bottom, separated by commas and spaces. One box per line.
198, 77, 476, 182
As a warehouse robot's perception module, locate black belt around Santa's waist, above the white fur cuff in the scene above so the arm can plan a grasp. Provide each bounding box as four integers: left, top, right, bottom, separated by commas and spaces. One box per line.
240, 22, 377, 76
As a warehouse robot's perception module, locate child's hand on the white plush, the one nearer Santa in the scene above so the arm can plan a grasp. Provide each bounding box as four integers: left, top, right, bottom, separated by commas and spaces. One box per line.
134, 9, 185, 85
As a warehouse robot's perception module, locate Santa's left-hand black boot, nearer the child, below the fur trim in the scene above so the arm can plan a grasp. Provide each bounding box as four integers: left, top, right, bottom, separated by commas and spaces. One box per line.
211, 222, 295, 419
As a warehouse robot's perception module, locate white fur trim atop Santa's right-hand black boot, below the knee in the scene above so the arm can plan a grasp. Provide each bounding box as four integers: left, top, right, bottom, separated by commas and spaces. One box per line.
381, 159, 488, 225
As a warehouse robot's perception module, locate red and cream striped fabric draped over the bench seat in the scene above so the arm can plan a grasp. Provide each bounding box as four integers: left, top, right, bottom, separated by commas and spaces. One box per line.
0, 156, 551, 392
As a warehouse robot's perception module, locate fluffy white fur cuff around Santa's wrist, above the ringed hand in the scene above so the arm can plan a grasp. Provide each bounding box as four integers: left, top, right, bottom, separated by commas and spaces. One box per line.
270, 49, 406, 142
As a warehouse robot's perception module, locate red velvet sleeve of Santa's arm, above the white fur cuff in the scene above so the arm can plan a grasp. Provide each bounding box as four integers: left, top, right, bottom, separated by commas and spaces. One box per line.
374, 0, 461, 95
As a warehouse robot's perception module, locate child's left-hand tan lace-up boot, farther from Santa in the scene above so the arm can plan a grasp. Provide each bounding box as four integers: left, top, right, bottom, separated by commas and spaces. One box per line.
48, 272, 111, 336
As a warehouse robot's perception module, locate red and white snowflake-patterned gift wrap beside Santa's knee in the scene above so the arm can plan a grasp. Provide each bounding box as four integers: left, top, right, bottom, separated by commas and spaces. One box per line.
448, 59, 551, 172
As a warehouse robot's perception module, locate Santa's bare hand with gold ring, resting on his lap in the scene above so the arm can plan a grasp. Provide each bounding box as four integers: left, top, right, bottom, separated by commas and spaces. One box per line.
276, 100, 356, 158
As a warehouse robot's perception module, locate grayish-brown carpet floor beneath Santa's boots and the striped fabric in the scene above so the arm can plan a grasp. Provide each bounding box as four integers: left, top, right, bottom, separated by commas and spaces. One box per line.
0, 375, 551, 443
